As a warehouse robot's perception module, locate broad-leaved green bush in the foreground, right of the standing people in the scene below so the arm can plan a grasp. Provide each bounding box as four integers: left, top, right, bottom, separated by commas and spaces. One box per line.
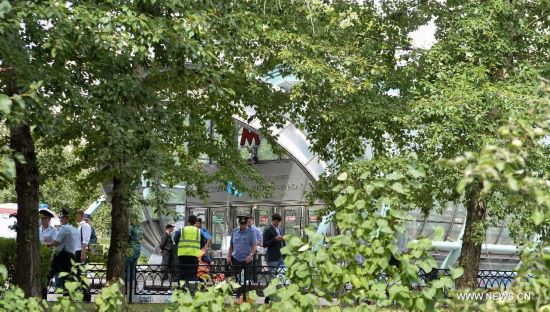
277, 160, 454, 310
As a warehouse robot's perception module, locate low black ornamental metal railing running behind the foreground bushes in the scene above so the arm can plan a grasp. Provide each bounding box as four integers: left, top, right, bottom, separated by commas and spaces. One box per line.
44, 261, 517, 302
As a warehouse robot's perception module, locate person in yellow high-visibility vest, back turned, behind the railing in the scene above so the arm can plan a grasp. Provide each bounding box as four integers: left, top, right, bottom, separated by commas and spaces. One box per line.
174, 215, 204, 282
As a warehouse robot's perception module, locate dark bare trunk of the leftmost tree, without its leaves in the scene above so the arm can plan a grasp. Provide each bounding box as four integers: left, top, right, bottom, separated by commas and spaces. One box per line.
10, 123, 41, 297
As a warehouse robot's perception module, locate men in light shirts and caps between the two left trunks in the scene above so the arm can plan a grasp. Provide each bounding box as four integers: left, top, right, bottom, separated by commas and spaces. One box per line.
39, 209, 96, 302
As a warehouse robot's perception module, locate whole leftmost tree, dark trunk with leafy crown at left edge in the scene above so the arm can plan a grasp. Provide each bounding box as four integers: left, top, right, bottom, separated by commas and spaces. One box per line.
0, 1, 101, 296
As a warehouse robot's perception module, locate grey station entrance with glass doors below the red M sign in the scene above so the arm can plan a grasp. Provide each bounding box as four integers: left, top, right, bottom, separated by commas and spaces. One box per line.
184, 159, 332, 250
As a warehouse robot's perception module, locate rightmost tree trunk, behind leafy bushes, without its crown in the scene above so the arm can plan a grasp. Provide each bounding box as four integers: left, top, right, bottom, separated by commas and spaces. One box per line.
456, 182, 487, 289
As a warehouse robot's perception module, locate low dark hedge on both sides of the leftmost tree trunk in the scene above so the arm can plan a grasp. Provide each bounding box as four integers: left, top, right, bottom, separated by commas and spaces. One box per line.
0, 237, 53, 286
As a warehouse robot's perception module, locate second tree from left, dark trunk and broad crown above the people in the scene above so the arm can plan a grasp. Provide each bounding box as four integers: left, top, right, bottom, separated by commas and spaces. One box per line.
44, 1, 306, 280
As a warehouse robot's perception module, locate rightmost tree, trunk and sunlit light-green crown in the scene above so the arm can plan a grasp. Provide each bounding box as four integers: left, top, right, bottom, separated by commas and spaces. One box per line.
404, 1, 550, 288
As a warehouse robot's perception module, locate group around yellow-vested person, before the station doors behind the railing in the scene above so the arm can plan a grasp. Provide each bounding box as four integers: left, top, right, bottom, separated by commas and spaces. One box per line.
160, 214, 284, 281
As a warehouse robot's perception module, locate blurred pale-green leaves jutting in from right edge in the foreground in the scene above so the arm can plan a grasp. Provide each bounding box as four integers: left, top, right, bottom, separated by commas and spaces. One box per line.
445, 92, 550, 242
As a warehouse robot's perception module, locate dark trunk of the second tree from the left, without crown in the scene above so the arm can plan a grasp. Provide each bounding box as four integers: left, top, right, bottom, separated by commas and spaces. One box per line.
107, 176, 129, 282
